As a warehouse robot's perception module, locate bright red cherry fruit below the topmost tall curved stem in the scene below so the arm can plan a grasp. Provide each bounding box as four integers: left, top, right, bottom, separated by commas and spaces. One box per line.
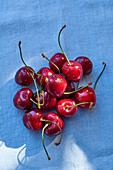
62, 61, 83, 82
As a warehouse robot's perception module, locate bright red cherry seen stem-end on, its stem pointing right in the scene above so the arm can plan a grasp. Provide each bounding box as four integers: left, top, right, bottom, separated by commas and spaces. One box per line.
56, 99, 78, 117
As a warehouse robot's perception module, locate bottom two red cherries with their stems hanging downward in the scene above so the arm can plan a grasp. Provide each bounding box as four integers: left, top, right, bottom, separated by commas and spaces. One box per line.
23, 108, 64, 160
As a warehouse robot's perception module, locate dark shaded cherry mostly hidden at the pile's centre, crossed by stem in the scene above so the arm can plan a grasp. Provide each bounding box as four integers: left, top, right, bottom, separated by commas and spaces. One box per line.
61, 81, 75, 99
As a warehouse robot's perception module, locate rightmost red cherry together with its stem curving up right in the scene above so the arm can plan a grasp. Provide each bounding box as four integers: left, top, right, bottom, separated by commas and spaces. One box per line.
74, 62, 106, 108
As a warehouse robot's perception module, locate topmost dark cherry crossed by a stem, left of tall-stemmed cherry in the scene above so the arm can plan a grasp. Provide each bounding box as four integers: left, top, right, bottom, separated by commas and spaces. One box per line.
49, 53, 67, 73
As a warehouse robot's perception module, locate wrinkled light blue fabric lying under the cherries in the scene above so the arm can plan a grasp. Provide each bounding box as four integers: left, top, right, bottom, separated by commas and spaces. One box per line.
0, 0, 113, 170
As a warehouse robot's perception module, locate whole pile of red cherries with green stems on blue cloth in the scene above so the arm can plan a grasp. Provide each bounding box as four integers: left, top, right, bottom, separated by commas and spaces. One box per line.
13, 25, 106, 160
